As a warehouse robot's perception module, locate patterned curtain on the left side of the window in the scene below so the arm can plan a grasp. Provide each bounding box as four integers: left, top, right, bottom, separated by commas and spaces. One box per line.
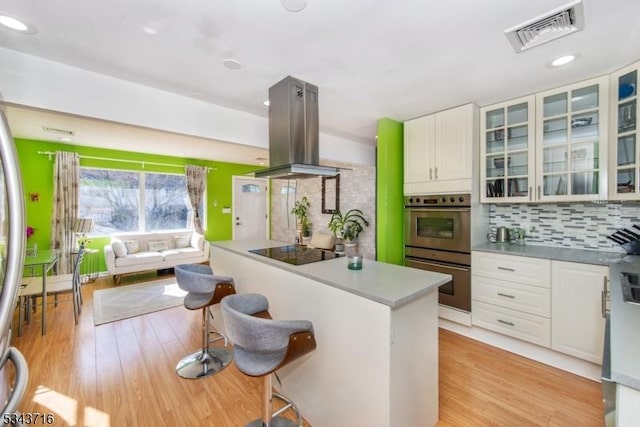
51, 151, 80, 274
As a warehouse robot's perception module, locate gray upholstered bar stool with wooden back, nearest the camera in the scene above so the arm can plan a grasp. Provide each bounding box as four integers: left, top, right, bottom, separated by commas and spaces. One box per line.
222, 294, 316, 427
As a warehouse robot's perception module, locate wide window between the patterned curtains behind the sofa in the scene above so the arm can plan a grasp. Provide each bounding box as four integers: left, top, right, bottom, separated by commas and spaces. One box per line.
79, 168, 202, 234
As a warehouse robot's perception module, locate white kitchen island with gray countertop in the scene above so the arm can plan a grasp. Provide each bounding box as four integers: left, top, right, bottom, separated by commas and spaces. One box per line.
210, 240, 451, 427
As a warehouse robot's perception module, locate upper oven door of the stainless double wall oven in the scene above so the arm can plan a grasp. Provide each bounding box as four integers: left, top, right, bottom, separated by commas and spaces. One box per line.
404, 208, 471, 252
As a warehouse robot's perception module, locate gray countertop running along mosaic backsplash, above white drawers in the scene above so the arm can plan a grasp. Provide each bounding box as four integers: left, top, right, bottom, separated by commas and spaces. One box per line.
471, 242, 626, 265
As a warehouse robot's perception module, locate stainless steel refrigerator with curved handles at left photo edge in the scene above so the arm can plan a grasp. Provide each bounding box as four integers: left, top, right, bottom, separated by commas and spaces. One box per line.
0, 103, 28, 418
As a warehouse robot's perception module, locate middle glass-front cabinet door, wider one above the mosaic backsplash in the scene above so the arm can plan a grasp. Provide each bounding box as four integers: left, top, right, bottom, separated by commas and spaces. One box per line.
532, 77, 609, 201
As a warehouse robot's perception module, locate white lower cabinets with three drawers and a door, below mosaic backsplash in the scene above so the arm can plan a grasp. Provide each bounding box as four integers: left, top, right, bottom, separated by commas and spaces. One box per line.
471, 251, 609, 364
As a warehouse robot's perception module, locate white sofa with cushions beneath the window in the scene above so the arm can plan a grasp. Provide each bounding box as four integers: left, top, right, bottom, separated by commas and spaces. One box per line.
104, 231, 209, 285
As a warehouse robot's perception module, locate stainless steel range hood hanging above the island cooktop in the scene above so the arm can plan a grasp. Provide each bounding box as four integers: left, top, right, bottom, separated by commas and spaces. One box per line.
255, 76, 338, 179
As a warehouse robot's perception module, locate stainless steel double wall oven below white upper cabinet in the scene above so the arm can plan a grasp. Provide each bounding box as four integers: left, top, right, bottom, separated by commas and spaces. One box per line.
404, 194, 471, 312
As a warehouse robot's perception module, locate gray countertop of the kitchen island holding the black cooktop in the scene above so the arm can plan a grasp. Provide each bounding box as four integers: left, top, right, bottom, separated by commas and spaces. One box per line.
210, 240, 451, 308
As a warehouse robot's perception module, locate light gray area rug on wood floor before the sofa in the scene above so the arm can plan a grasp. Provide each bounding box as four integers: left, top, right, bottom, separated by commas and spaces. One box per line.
93, 277, 187, 326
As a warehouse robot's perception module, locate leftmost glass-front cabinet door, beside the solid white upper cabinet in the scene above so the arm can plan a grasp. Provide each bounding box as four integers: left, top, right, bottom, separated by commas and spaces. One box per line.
480, 96, 535, 203
